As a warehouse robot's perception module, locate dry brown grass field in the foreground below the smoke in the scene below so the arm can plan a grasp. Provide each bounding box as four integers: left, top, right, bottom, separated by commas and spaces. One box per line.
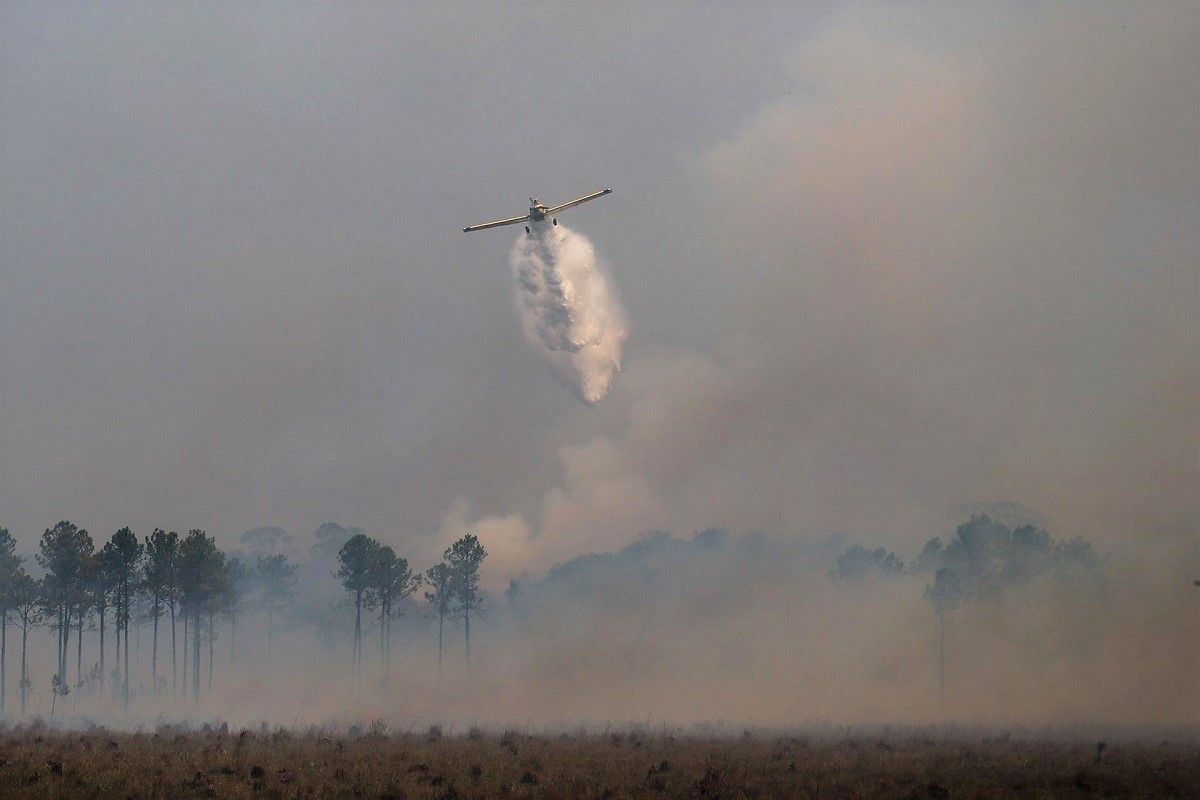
0, 726, 1200, 800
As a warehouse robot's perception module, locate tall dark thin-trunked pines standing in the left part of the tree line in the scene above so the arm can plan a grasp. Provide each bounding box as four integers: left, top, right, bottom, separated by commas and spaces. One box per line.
0, 521, 487, 715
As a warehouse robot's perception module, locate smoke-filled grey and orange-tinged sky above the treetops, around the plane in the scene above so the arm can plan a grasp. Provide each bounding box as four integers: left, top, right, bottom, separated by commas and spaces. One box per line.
0, 2, 1200, 579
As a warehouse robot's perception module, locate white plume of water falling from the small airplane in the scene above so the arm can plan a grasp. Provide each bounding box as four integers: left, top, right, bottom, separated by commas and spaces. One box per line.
509, 224, 629, 405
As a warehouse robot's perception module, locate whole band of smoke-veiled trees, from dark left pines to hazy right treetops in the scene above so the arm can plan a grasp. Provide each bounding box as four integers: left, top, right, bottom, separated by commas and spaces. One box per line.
0, 515, 1104, 717
